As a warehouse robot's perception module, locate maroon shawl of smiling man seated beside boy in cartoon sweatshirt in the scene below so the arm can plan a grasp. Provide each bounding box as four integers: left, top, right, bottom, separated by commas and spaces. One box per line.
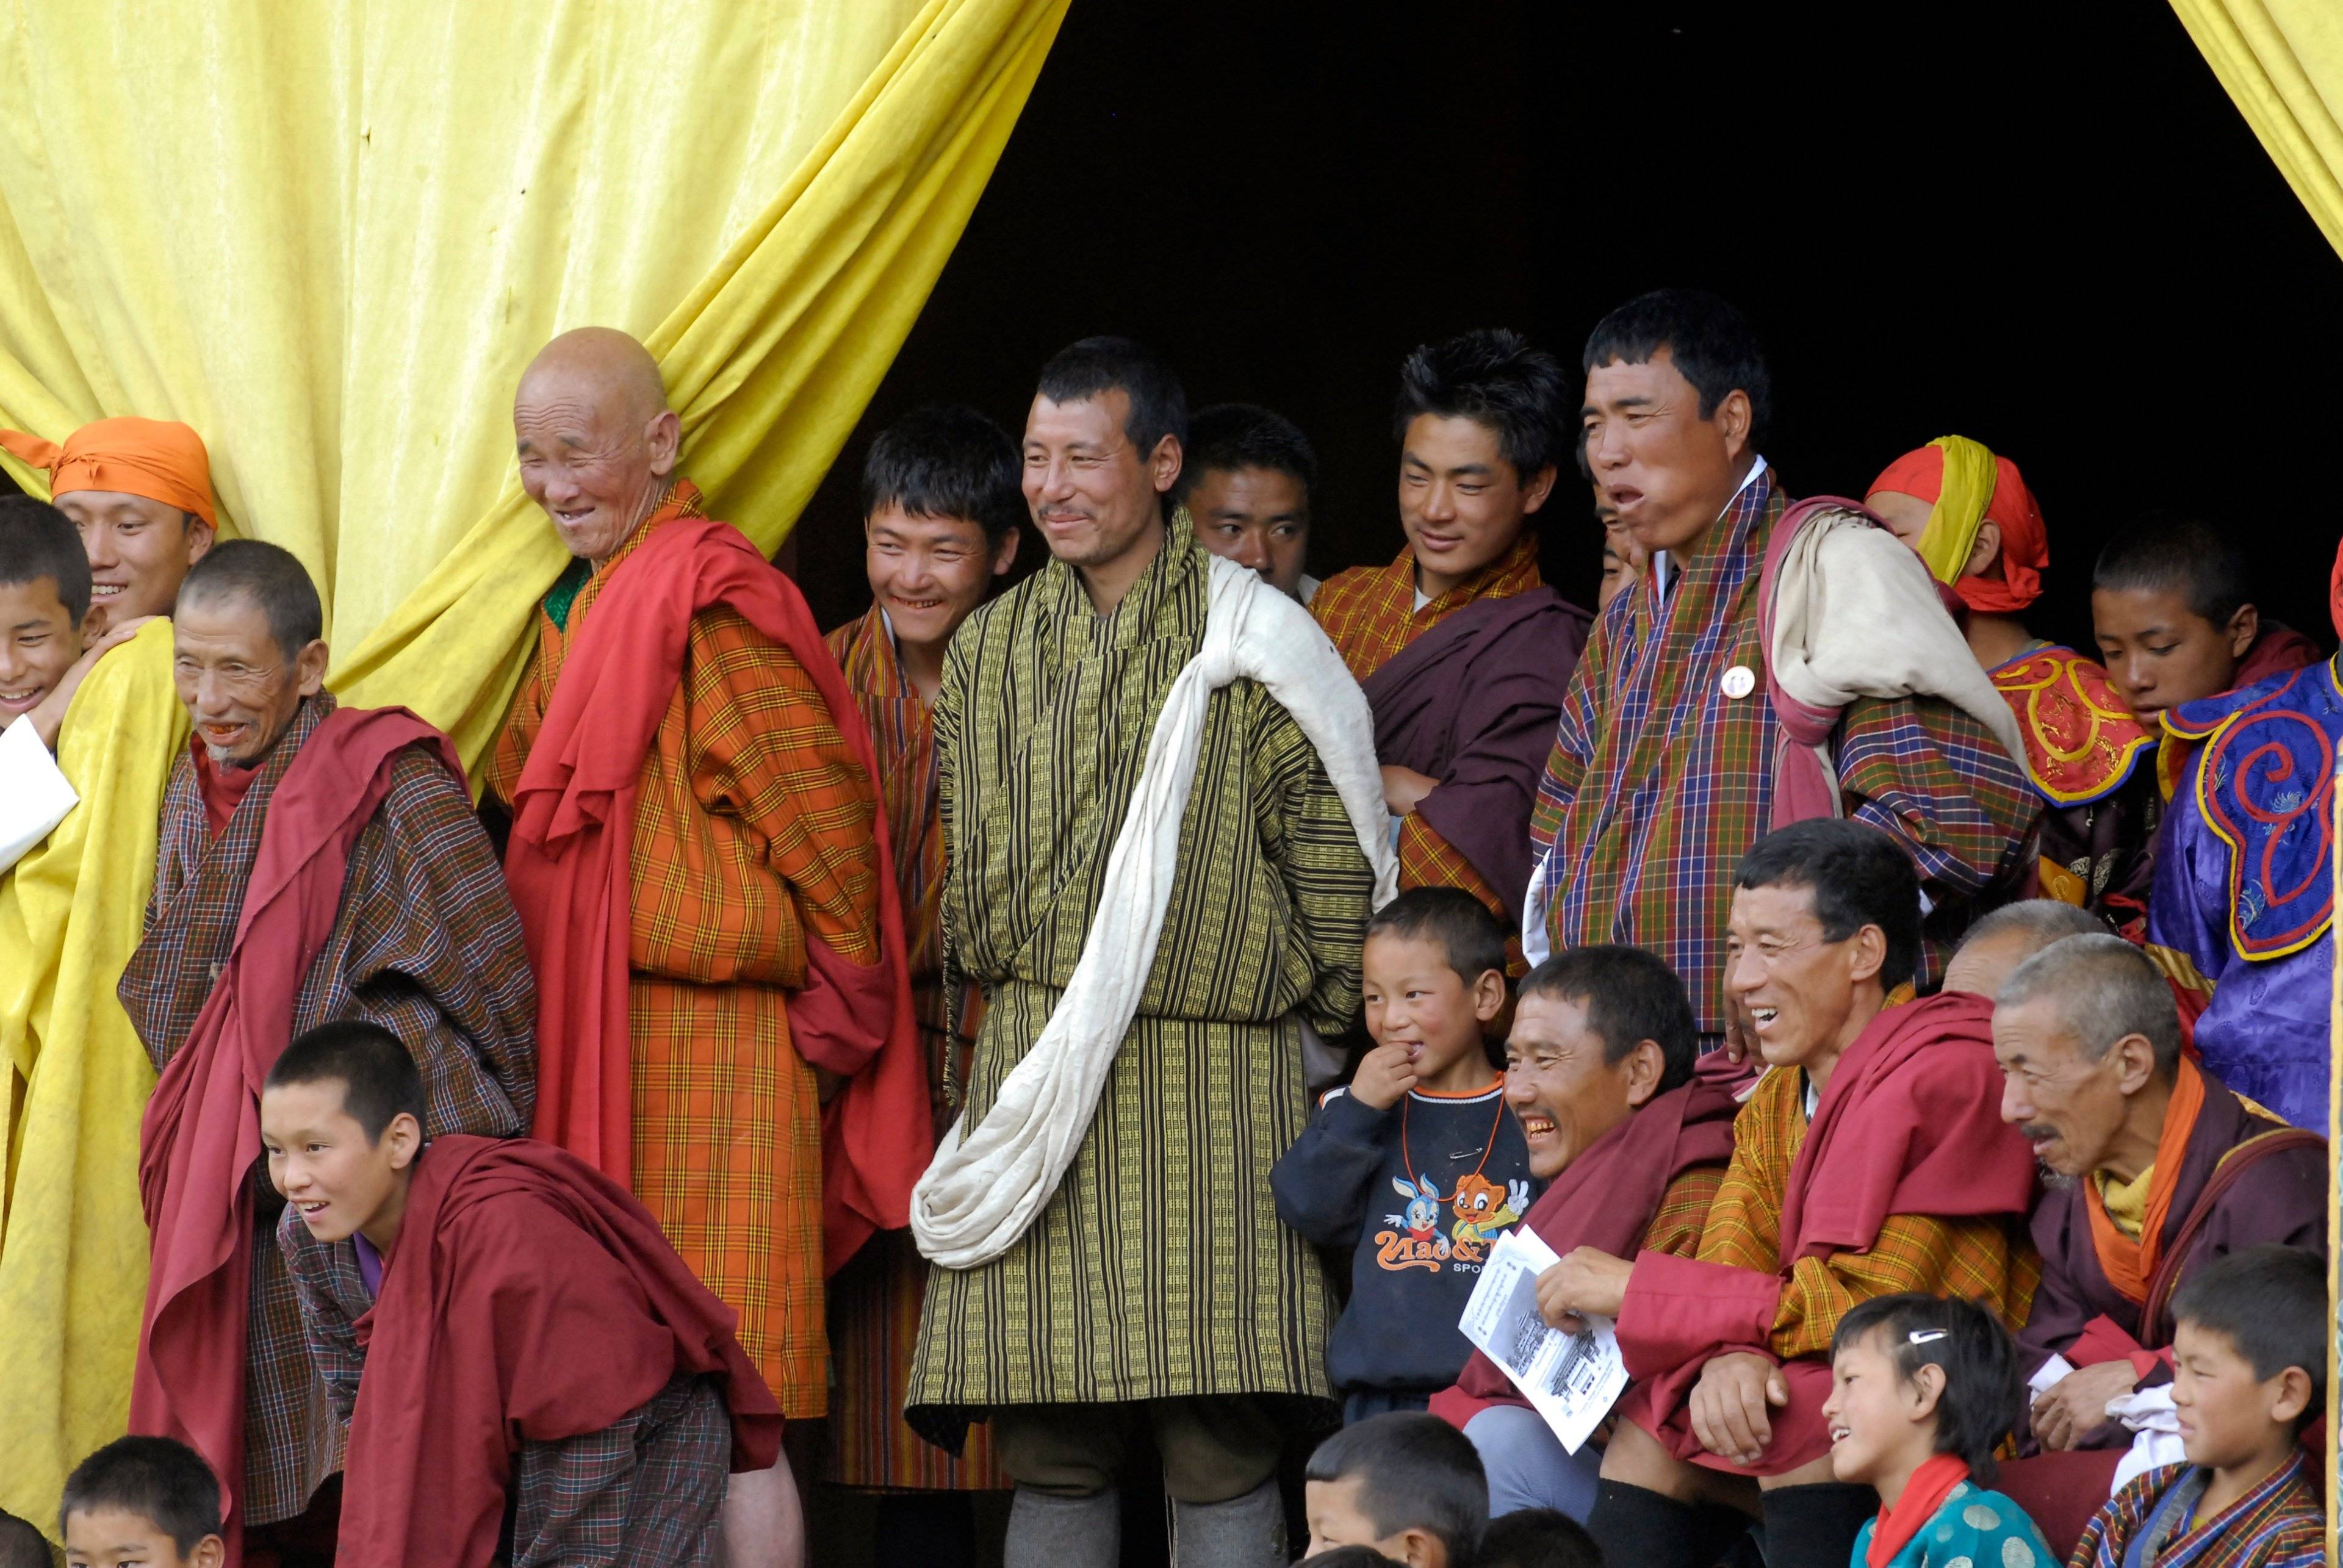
1431, 1050, 1746, 1432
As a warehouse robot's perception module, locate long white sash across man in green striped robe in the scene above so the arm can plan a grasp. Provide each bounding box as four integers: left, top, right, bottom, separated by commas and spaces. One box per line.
912, 555, 1398, 1268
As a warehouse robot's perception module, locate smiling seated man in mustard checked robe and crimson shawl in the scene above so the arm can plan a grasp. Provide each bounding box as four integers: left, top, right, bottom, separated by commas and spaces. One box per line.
1539, 818, 2036, 1568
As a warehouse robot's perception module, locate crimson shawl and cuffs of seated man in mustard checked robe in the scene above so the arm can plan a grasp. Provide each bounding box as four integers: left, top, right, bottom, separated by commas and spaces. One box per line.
1619, 991, 2036, 1474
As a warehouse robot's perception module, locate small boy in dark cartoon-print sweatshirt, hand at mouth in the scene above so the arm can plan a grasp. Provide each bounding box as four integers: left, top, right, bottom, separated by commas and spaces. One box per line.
1270, 888, 1530, 1423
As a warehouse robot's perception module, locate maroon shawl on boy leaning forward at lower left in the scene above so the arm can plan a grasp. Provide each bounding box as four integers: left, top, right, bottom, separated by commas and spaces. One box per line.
335, 1137, 780, 1568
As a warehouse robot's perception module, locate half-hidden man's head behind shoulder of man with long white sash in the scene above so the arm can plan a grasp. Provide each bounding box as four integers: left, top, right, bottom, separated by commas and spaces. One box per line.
1190, 403, 1322, 605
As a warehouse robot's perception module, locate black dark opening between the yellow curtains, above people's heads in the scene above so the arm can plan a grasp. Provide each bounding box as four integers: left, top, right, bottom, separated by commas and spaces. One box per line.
794, 0, 2343, 647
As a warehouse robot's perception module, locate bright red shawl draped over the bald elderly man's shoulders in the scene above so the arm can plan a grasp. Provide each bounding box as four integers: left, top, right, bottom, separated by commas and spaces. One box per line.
504, 518, 932, 1273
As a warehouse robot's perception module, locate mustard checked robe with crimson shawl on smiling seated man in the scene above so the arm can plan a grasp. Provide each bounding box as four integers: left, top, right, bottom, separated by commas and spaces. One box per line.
1619, 991, 2041, 1474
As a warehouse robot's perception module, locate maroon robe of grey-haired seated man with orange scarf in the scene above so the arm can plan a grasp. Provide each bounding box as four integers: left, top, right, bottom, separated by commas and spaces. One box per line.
2017, 1073, 2327, 1448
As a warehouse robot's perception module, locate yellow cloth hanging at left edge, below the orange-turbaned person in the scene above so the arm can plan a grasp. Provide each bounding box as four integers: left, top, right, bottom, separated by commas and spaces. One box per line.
0, 621, 187, 1531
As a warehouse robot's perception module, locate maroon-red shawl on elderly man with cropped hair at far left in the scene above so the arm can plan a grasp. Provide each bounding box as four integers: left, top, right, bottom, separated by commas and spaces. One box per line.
131, 708, 464, 1549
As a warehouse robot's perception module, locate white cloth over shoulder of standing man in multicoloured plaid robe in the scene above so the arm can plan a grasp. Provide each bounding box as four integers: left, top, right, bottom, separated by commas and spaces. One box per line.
1766, 511, 2027, 766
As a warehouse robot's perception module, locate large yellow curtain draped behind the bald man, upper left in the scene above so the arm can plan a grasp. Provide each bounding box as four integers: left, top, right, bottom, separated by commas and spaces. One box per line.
0, 0, 1066, 762
